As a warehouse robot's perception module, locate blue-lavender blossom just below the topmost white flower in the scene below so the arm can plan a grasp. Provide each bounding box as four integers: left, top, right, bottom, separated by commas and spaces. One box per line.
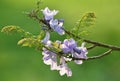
49, 19, 65, 35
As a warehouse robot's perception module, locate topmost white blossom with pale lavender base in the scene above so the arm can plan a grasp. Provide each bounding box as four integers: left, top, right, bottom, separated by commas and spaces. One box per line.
41, 7, 58, 21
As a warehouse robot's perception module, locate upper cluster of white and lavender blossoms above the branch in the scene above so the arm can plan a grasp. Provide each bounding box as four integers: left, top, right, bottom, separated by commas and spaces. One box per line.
41, 7, 65, 35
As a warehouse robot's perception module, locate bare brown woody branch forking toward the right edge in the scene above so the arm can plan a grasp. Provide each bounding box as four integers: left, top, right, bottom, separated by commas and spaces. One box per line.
26, 12, 120, 60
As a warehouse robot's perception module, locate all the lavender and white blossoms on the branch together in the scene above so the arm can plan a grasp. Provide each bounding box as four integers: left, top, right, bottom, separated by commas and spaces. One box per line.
41, 7, 88, 77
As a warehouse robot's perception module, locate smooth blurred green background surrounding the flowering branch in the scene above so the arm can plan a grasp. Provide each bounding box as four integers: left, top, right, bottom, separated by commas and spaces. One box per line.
0, 0, 120, 81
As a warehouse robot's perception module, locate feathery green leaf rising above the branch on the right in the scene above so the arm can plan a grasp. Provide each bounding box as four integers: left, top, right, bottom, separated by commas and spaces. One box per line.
72, 13, 96, 36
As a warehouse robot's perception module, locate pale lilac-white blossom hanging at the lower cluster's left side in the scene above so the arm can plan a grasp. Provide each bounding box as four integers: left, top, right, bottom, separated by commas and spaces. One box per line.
42, 48, 58, 70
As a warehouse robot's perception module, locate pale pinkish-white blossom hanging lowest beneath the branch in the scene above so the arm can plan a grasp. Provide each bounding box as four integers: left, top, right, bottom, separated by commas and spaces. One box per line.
59, 57, 72, 77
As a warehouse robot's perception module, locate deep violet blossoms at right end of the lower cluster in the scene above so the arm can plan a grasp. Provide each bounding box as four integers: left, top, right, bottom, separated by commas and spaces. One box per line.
61, 38, 88, 64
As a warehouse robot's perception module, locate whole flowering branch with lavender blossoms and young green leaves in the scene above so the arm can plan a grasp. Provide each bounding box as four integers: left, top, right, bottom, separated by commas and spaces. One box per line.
2, 3, 120, 77
